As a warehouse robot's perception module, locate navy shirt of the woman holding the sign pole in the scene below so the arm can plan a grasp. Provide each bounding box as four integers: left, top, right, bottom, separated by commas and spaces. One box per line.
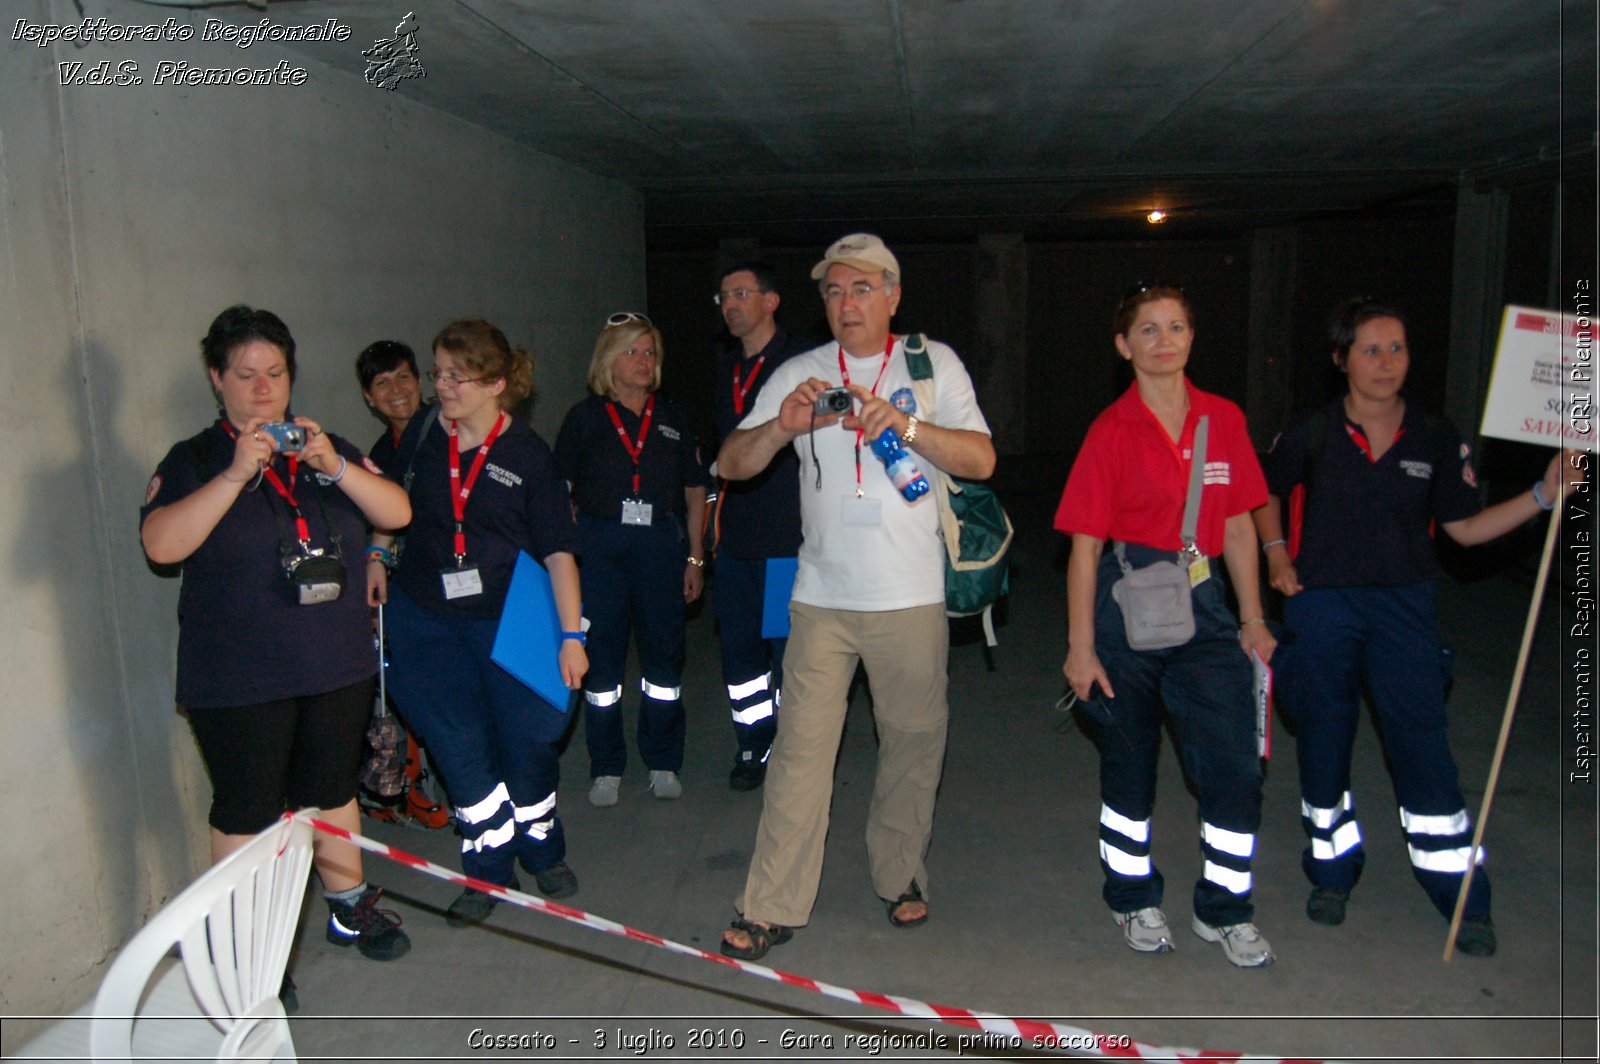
1264, 397, 1483, 587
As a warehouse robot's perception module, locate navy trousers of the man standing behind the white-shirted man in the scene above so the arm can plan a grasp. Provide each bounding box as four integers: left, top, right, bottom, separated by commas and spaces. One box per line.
714, 552, 789, 763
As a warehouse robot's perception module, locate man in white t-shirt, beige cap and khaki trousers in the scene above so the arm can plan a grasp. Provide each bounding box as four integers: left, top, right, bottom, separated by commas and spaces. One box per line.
717, 234, 995, 960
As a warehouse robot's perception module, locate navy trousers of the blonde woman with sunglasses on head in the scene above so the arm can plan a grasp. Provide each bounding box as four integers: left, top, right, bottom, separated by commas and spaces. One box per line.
578, 514, 688, 776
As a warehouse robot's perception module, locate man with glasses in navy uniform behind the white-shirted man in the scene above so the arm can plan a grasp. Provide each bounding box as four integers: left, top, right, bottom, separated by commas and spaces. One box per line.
707, 261, 816, 790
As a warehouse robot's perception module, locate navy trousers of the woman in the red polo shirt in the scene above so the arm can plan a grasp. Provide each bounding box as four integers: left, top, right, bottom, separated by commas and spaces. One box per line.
1094, 544, 1261, 926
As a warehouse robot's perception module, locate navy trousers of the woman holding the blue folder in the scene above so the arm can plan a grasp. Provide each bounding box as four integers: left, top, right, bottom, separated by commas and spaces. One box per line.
384, 584, 571, 885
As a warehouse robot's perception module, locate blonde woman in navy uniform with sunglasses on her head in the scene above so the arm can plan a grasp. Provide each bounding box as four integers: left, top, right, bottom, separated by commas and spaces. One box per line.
555, 312, 706, 806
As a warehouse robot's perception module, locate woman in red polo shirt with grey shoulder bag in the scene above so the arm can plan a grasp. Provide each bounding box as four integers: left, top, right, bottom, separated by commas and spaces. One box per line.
1056, 283, 1275, 968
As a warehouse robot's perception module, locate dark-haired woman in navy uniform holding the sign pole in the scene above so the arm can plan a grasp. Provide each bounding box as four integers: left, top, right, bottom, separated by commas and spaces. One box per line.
1256, 299, 1582, 957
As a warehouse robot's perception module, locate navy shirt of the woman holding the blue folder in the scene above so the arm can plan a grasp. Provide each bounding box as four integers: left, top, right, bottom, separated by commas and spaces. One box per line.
394, 418, 578, 618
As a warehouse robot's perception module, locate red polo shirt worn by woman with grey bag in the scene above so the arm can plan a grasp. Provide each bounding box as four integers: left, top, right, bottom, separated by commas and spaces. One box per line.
1056, 379, 1267, 558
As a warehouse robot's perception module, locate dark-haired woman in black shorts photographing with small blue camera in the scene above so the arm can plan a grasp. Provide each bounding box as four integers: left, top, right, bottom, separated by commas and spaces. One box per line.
139, 306, 411, 966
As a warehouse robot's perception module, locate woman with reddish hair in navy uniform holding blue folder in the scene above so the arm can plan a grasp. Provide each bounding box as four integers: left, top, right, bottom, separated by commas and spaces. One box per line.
387, 320, 589, 926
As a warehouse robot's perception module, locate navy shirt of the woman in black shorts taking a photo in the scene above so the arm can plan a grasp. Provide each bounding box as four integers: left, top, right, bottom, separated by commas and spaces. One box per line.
139, 421, 378, 709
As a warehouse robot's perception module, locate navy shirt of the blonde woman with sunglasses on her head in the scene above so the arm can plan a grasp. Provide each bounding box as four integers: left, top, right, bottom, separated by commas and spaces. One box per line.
555, 392, 706, 525
